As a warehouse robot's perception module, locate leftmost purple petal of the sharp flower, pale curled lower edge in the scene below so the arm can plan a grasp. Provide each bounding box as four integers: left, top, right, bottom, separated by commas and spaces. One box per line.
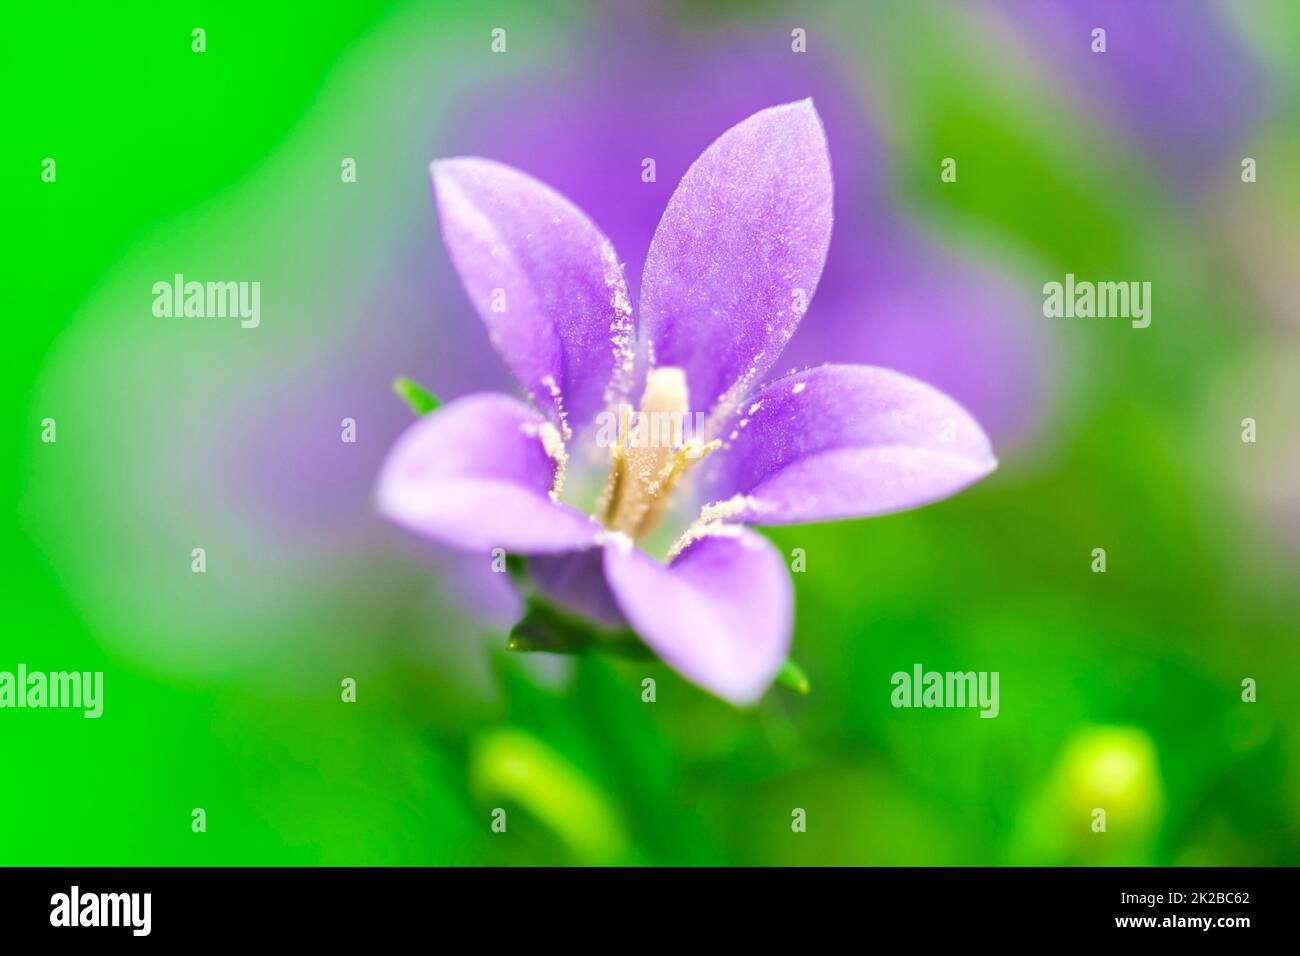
377, 393, 601, 554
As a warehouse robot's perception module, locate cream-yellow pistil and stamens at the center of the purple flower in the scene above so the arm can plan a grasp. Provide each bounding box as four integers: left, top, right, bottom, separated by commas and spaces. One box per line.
597, 367, 722, 541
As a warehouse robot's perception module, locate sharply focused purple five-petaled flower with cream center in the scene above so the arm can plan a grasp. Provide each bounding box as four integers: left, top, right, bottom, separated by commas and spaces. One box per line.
378, 100, 996, 704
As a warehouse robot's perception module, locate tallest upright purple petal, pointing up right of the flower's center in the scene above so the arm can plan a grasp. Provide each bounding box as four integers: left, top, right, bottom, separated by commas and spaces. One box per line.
640, 100, 832, 421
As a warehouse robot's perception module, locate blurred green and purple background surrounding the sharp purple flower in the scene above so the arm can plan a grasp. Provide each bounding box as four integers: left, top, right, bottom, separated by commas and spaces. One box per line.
0, 0, 1300, 865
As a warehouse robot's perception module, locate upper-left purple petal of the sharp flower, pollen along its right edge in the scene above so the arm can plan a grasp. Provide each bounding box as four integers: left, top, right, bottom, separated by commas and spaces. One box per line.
430, 157, 633, 428
